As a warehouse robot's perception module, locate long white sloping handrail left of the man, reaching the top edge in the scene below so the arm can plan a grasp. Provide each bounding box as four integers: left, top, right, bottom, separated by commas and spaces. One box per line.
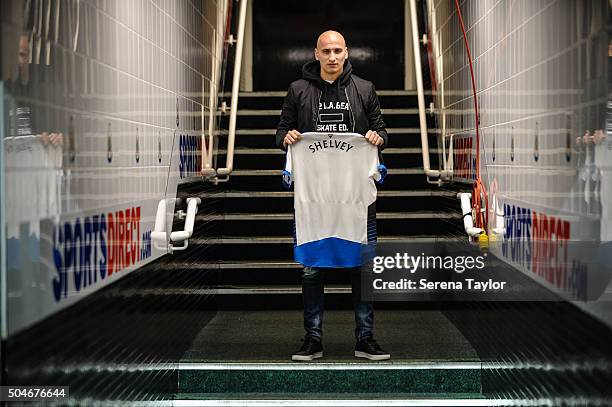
217, 0, 248, 175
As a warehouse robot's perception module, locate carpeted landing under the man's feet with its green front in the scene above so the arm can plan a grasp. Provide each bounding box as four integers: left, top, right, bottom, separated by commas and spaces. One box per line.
177, 310, 483, 396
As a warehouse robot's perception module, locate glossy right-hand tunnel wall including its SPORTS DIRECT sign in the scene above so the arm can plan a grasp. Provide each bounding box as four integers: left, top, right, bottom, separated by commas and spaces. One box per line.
427, 0, 612, 324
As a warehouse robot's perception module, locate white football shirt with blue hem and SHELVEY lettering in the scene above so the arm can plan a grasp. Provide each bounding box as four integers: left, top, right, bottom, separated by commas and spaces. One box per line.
283, 132, 387, 267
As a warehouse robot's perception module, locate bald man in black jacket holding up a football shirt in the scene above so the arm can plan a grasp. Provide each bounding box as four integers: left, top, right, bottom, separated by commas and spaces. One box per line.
276, 31, 391, 361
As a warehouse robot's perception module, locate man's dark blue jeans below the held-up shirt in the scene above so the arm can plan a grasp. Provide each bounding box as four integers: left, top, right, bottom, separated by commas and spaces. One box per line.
302, 267, 374, 341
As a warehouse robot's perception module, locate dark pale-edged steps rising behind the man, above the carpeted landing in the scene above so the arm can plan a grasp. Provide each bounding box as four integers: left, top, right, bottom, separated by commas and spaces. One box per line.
182, 91, 461, 308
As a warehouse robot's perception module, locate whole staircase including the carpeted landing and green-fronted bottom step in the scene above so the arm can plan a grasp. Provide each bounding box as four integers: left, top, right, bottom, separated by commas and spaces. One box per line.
167, 91, 486, 405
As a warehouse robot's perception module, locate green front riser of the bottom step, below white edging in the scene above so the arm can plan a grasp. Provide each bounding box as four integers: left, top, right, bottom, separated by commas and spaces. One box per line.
178, 361, 482, 396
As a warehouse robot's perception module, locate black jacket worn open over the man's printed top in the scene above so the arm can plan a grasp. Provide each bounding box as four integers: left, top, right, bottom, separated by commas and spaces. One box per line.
276, 60, 388, 150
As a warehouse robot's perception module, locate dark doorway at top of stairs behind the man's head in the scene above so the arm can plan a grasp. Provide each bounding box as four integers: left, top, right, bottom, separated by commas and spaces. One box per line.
252, 0, 405, 91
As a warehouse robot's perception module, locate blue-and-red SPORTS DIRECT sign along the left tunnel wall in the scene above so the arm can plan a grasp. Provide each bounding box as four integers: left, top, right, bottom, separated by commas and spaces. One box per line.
7, 201, 163, 333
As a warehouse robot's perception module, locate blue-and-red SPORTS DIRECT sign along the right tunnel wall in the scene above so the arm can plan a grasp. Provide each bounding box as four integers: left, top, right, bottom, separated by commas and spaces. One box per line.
498, 202, 612, 301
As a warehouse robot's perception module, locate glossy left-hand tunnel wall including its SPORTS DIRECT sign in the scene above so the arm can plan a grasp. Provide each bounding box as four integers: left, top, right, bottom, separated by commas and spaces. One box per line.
0, 0, 224, 335
